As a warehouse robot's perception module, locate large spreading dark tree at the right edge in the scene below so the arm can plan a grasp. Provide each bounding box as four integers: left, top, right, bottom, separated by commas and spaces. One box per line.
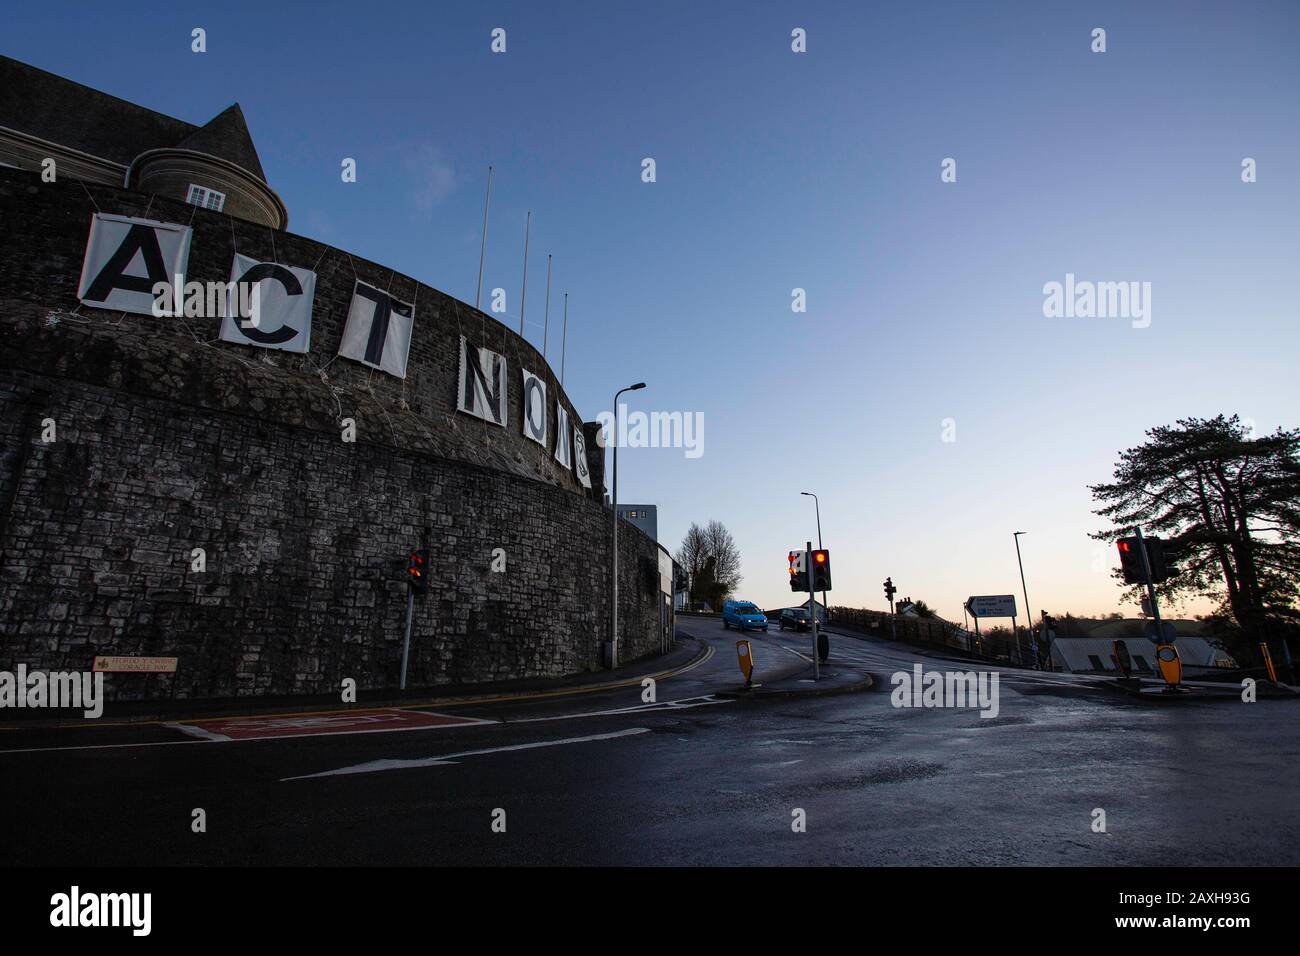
1089, 415, 1300, 641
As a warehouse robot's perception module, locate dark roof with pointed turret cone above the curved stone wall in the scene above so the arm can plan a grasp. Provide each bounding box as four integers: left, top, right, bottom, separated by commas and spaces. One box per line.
0, 56, 267, 182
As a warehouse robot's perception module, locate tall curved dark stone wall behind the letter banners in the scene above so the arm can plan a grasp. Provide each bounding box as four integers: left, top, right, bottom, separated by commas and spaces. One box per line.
0, 169, 660, 697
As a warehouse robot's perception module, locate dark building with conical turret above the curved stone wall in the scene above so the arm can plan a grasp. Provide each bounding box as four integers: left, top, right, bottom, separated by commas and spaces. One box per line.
0, 56, 289, 229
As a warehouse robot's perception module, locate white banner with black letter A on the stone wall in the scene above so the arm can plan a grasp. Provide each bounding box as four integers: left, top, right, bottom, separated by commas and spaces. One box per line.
77, 212, 191, 315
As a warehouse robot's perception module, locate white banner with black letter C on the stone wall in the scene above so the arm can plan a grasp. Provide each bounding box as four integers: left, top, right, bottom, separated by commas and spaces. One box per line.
221, 254, 316, 352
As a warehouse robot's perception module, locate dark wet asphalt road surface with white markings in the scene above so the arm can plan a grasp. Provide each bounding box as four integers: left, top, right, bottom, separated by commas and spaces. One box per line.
0, 618, 1300, 868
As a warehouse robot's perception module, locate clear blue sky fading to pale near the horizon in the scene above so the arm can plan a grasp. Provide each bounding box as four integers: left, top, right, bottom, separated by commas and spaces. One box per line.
0, 0, 1300, 619
